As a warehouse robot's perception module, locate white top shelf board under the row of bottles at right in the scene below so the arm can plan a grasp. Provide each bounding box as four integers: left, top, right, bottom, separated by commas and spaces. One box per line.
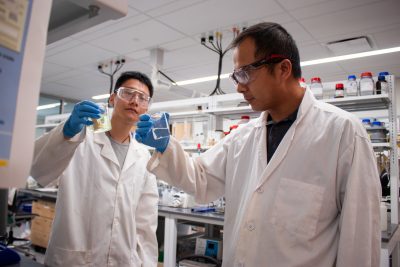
321, 94, 390, 112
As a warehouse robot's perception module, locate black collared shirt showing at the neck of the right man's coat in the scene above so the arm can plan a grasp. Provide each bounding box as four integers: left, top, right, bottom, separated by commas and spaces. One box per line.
267, 108, 299, 162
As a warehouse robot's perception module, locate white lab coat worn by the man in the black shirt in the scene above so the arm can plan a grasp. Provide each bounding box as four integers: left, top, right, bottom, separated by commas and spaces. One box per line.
148, 90, 380, 267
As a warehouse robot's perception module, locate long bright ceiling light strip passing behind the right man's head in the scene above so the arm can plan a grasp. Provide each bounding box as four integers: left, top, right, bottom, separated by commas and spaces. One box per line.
174, 46, 400, 86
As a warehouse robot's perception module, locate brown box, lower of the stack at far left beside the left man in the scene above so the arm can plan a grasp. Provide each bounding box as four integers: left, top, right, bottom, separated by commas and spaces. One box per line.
31, 216, 53, 248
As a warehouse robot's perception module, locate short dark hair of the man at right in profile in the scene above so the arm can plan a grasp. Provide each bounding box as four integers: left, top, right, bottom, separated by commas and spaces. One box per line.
231, 22, 301, 78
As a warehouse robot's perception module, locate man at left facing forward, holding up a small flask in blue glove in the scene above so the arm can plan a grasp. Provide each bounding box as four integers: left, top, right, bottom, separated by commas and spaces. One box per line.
31, 72, 158, 267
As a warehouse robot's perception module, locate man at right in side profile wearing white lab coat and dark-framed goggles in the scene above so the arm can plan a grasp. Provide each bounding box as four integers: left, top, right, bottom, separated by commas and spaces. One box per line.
136, 23, 380, 267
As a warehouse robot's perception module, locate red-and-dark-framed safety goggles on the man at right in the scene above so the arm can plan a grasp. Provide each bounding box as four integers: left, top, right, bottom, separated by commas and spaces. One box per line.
229, 54, 287, 86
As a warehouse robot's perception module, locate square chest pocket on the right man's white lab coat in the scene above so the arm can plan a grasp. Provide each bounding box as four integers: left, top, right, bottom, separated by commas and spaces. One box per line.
270, 178, 325, 240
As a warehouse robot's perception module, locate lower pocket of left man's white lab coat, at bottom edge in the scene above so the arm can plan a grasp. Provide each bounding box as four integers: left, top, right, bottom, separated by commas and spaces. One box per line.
48, 247, 92, 266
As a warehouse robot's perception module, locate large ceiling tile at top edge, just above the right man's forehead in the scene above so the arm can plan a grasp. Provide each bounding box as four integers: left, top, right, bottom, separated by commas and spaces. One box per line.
158, 0, 283, 35
